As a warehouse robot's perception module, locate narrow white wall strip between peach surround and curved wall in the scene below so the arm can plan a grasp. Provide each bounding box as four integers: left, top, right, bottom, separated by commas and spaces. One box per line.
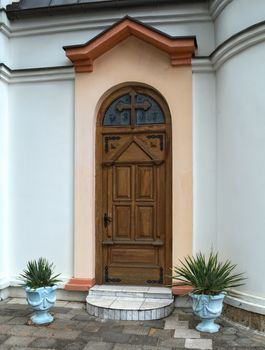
192, 73, 216, 253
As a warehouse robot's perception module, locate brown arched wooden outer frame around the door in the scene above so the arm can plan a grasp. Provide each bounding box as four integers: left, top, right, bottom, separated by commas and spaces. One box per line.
95, 84, 173, 284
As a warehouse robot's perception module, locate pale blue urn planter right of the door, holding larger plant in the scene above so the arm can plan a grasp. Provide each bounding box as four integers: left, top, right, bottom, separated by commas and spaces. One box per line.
190, 293, 225, 333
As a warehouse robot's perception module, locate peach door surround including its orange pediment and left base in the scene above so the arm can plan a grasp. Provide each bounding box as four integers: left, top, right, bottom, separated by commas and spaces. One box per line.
65, 17, 195, 290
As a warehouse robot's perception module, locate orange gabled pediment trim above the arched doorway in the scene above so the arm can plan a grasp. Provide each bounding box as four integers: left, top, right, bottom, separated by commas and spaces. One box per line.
64, 16, 196, 73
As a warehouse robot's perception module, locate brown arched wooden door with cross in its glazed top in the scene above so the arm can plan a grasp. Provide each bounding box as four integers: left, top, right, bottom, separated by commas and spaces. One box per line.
96, 86, 172, 285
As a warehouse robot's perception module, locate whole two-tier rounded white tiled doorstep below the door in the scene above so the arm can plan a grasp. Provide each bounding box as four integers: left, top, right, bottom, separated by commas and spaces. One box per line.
86, 285, 174, 321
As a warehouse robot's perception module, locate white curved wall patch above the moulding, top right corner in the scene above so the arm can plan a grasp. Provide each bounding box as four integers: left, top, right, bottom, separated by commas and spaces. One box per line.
215, 0, 265, 46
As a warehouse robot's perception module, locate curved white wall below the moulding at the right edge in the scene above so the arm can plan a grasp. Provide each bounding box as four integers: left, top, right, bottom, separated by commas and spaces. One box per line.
217, 42, 265, 297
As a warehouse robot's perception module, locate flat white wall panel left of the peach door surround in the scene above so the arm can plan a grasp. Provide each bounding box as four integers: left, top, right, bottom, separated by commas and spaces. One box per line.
8, 81, 74, 277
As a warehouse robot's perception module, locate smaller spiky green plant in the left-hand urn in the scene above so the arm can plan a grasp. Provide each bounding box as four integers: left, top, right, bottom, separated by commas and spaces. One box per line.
19, 258, 61, 289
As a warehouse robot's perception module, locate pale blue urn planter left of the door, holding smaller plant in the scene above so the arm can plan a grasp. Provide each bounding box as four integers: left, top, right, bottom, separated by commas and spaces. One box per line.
25, 286, 57, 324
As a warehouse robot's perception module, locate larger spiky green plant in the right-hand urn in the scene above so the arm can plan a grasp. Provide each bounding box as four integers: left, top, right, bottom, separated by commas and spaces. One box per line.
172, 251, 246, 295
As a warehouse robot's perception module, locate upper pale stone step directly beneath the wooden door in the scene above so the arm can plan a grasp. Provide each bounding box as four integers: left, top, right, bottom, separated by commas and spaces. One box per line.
89, 285, 172, 299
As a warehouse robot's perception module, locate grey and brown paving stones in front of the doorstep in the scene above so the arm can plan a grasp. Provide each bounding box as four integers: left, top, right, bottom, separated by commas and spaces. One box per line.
0, 302, 265, 350
